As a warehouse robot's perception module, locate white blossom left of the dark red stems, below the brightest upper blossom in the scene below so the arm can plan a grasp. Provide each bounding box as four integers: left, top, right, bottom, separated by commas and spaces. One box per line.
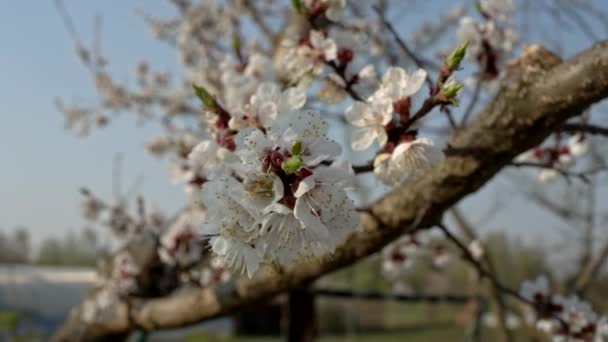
345, 97, 393, 150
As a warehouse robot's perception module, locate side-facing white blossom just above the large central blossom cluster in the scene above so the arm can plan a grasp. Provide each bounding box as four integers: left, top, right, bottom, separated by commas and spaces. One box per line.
228, 82, 306, 130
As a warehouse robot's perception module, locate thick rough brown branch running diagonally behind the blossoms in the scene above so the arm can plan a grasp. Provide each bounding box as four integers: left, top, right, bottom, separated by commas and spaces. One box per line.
55, 42, 608, 341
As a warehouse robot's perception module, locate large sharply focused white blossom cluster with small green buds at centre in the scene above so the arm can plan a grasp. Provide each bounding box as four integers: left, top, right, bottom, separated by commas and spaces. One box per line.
202, 110, 359, 276
